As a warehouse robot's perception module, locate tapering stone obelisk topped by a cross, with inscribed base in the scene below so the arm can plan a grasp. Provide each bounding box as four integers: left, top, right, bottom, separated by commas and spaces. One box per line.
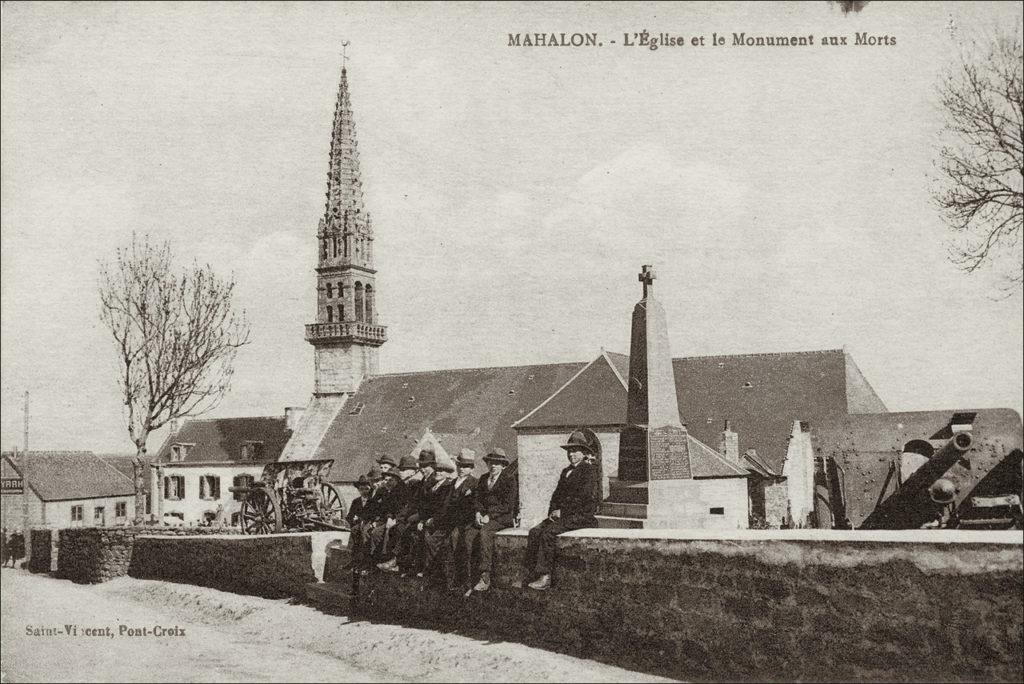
618, 265, 692, 482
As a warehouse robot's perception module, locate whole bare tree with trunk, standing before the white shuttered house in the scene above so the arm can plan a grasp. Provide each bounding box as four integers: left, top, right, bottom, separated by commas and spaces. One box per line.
99, 234, 250, 524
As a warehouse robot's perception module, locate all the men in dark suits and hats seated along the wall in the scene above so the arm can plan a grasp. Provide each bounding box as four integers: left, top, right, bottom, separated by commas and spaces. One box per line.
347, 431, 599, 595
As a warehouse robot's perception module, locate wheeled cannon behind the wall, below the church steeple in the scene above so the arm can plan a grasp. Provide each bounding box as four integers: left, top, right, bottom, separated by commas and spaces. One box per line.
229, 459, 348, 535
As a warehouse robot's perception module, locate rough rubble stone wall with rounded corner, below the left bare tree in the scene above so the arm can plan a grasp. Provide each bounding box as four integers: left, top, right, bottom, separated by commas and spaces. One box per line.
56, 526, 239, 584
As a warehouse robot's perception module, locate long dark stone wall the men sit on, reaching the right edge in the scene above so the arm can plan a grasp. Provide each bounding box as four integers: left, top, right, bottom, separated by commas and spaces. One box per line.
357, 529, 1024, 681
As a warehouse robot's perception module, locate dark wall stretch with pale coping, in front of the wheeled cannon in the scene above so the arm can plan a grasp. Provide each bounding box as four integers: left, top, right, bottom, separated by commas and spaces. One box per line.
129, 533, 316, 598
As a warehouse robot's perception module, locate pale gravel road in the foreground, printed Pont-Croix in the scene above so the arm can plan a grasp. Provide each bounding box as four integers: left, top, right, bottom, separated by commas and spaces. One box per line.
0, 568, 670, 682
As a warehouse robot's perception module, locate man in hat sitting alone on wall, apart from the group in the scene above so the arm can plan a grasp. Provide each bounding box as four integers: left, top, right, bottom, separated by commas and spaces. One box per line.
525, 430, 600, 590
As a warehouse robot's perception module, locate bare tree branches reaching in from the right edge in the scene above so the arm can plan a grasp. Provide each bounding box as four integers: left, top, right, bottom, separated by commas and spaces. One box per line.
935, 27, 1024, 294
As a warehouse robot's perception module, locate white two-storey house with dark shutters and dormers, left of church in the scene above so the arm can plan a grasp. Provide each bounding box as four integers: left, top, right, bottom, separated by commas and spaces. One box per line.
150, 409, 299, 525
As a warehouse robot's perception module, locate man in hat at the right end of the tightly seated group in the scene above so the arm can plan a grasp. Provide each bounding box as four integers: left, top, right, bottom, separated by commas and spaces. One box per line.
467, 447, 519, 592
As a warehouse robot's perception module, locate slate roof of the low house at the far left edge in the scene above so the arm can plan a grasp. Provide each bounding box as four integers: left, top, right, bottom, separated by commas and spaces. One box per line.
4, 452, 134, 501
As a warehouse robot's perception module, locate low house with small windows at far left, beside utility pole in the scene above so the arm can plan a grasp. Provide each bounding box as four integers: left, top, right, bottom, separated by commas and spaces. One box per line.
2, 452, 135, 529
